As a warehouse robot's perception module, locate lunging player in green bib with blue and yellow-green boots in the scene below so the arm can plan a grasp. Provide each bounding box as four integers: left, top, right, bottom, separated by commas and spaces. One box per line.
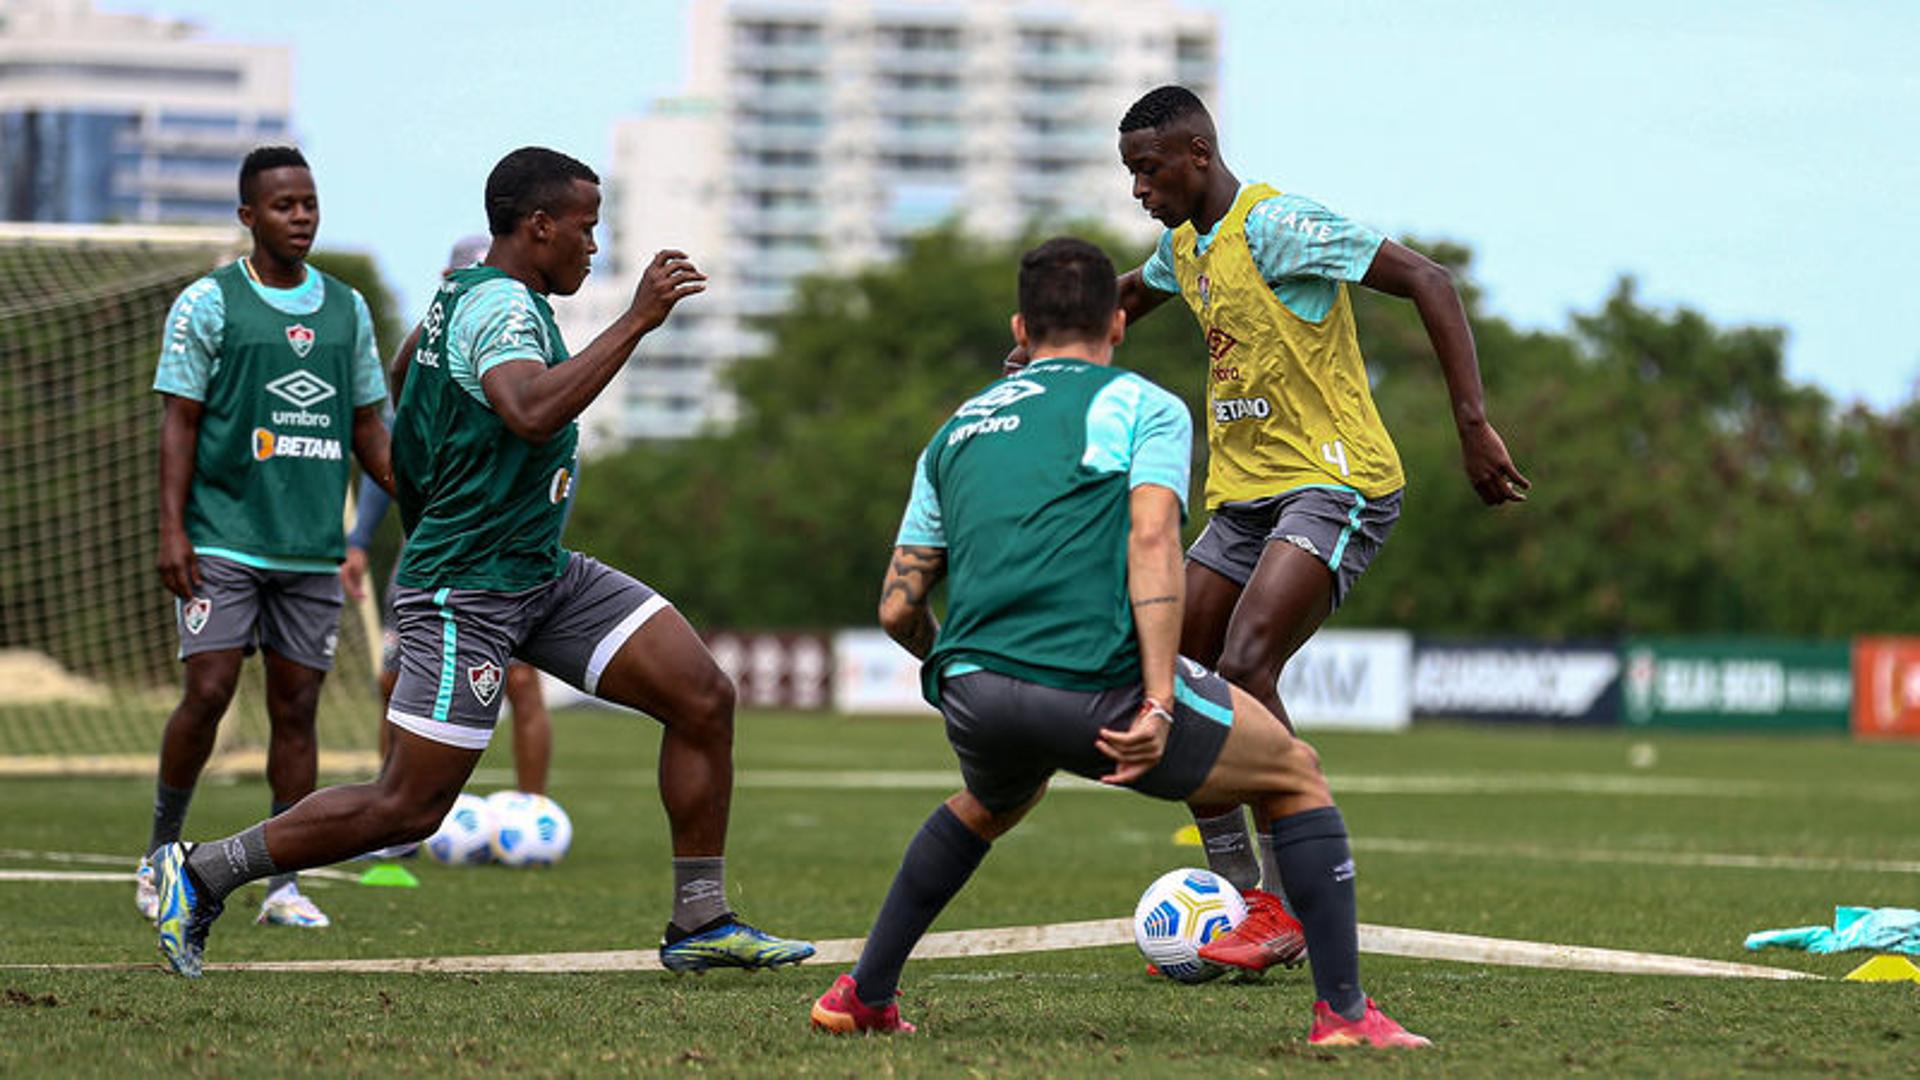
156, 146, 814, 976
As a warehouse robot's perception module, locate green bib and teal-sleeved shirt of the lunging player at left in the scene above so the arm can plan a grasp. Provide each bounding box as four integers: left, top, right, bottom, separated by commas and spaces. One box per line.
394, 267, 580, 592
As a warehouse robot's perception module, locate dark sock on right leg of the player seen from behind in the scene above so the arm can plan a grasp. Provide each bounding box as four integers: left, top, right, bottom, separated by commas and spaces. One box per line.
1273, 807, 1367, 1020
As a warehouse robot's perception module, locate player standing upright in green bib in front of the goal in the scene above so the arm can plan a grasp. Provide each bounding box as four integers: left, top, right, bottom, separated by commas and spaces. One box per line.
134, 146, 394, 928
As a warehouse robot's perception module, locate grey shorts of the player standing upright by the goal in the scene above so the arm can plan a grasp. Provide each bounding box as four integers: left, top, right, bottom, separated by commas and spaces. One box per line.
173, 555, 342, 671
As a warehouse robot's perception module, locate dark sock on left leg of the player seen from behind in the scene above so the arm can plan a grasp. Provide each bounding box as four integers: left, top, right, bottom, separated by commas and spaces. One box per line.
852, 803, 991, 1009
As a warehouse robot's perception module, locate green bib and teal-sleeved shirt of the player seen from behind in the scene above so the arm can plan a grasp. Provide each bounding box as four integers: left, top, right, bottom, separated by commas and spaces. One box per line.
897, 357, 1192, 703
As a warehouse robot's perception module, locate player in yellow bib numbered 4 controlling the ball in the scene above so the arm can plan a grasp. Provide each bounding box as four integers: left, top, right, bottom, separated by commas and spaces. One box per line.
1010, 86, 1528, 970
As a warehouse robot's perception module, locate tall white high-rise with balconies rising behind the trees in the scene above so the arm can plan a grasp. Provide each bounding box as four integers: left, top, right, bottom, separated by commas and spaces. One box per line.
561, 0, 1219, 446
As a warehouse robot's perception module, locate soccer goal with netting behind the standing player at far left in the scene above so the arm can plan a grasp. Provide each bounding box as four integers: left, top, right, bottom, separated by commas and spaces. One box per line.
0, 223, 380, 776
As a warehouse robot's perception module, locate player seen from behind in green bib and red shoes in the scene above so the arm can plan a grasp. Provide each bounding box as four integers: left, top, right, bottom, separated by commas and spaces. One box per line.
812, 236, 1428, 1047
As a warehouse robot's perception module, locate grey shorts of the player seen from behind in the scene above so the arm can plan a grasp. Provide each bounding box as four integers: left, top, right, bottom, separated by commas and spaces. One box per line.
941, 657, 1233, 813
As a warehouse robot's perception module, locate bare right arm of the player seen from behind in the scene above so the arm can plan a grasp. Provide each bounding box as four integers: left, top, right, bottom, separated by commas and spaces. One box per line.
1098, 484, 1185, 784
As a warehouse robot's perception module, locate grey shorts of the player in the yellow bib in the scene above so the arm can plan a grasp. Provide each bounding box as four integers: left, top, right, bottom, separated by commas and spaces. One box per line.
1187, 488, 1400, 609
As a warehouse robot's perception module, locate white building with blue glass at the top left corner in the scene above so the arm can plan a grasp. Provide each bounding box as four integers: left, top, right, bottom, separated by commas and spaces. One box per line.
0, 0, 292, 223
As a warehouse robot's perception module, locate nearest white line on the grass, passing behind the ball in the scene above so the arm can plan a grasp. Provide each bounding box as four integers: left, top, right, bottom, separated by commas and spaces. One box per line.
0, 919, 1820, 980
